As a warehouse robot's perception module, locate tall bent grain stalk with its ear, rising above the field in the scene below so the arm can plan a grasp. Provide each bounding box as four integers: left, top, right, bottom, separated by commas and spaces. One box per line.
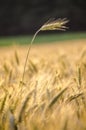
21, 18, 68, 83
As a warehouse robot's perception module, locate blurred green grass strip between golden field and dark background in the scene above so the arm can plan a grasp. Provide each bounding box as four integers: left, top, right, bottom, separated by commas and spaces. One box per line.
0, 32, 86, 46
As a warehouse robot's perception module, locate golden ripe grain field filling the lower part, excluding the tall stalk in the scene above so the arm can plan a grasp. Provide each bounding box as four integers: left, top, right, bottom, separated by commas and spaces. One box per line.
0, 40, 86, 130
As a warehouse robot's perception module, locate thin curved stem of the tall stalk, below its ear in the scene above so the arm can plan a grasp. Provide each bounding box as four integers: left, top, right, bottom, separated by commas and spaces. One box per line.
21, 29, 40, 83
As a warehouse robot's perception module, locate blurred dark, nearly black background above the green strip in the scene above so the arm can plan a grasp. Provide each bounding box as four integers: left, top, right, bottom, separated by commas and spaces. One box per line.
0, 0, 86, 36
